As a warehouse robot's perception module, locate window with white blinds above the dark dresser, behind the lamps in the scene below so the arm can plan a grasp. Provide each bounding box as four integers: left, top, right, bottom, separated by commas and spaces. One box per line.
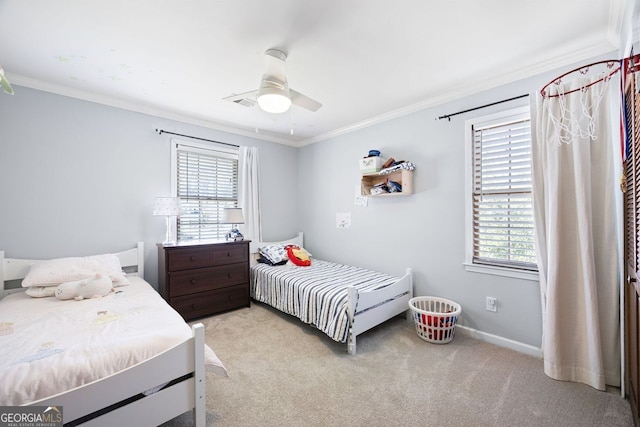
171, 142, 238, 241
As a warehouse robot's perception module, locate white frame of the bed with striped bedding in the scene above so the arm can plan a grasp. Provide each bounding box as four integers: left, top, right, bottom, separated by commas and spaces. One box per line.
249, 232, 413, 355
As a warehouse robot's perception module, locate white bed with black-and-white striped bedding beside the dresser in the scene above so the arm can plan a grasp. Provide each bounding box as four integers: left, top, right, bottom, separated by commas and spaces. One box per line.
250, 233, 413, 355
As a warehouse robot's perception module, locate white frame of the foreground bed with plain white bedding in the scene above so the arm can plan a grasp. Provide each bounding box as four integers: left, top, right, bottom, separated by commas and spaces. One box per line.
0, 242, 206, 427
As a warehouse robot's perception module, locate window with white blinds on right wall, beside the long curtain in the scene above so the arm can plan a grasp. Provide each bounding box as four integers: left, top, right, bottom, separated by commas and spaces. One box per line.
466, 107, 538, 279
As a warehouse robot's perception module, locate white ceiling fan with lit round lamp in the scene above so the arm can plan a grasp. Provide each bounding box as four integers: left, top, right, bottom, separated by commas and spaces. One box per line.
223, 49, 322, 113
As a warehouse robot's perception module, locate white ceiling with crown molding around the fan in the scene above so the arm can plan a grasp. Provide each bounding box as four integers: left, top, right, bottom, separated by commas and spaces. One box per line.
0, 0, 634, 146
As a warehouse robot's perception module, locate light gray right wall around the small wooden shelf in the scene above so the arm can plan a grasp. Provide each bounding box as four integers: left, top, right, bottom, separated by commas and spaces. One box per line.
299, 54, 616, 347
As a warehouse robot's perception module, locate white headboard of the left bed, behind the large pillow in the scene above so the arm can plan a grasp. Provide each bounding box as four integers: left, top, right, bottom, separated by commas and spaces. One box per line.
0, 242, 144, 298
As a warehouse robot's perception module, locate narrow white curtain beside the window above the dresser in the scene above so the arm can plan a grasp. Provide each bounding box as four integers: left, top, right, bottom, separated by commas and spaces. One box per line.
238, 147, 262, 242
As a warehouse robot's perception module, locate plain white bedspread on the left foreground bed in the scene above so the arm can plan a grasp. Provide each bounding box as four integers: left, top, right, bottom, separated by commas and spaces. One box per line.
0, 277, 224, 406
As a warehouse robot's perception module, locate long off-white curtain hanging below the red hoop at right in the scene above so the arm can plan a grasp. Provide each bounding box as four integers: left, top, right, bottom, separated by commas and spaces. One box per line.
532, 77, 621, 390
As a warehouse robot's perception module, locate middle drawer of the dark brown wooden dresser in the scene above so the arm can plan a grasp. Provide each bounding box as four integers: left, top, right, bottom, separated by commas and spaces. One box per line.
169, 263, 249, 298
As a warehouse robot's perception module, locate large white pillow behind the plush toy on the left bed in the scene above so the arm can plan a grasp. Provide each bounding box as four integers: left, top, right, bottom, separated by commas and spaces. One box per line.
22, 254, 129, 287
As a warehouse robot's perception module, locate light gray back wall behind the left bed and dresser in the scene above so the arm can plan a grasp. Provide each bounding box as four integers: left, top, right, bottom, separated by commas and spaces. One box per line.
0, 86, 299, 286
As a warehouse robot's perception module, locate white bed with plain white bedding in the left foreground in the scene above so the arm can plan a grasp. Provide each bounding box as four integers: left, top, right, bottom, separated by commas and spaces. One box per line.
0, 243, 224, 426
